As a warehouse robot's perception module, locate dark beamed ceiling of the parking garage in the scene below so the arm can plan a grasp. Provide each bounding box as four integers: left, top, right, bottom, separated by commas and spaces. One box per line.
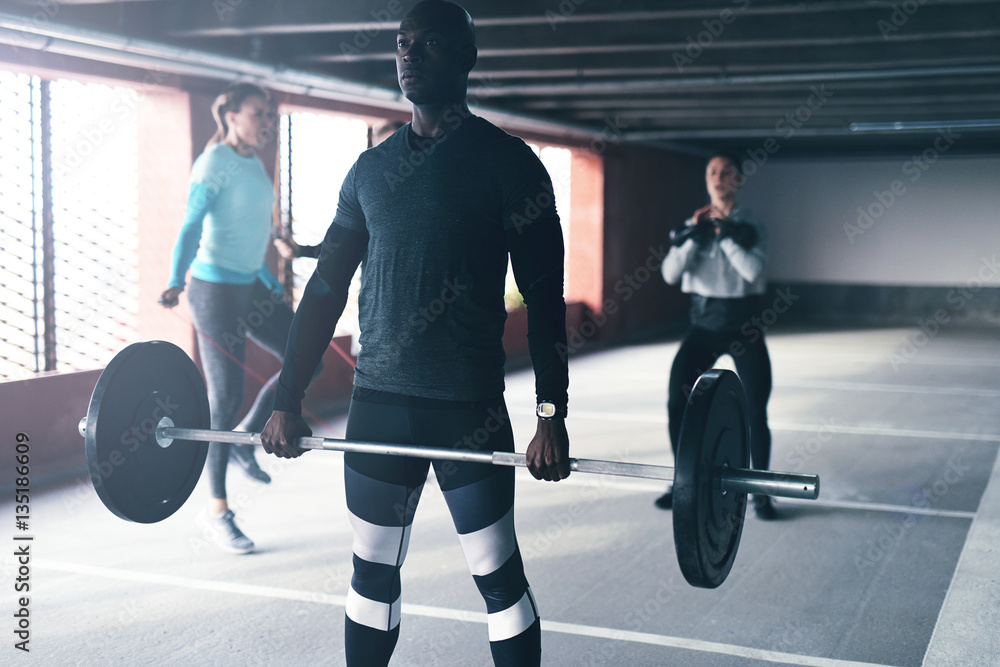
0, 0, 1000, 155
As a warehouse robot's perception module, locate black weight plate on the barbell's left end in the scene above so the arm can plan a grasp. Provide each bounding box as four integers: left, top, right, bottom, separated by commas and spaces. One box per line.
85, 341, 211, 523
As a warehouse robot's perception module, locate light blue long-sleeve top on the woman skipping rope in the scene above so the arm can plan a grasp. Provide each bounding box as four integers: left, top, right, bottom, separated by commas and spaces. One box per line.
168, 144, 280, 289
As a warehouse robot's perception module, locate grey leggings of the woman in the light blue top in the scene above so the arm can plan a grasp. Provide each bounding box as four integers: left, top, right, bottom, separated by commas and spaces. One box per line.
188, 278, 292, 499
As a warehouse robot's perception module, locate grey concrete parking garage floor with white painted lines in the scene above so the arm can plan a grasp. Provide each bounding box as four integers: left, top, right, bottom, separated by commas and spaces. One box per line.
0, 328, 1000, 667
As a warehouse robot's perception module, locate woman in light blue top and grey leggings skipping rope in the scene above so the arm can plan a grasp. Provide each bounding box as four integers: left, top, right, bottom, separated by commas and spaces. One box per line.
160, 83, 312, 553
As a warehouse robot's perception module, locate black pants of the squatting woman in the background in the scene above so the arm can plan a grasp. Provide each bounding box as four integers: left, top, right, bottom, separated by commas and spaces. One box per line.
667, 327, 771, 470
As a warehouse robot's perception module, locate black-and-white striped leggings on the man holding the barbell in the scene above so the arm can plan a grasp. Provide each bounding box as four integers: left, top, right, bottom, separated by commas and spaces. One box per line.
344, 388, 541, 667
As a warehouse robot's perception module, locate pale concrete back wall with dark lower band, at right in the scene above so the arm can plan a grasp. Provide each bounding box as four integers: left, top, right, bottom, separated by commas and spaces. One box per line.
740, 155, 1000, 324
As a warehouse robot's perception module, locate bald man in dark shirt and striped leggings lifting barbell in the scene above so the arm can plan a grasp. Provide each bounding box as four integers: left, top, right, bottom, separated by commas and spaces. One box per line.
261, 0, 569, 666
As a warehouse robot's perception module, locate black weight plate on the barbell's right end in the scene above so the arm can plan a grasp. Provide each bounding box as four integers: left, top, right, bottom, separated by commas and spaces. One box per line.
674, 369, 750, 588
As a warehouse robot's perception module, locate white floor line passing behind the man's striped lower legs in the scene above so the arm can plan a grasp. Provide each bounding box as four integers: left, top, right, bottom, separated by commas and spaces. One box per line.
34, 559, 888, 667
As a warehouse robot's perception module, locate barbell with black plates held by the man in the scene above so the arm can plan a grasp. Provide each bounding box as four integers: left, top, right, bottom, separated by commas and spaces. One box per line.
79, 341, 819, 588
